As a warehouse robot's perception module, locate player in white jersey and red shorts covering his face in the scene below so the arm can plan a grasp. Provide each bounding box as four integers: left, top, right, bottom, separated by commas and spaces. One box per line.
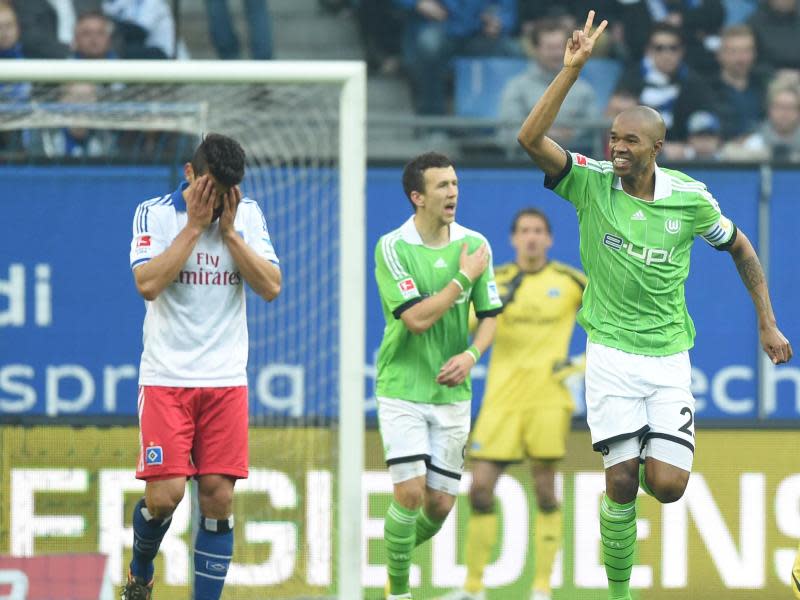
122, 134, 281, 600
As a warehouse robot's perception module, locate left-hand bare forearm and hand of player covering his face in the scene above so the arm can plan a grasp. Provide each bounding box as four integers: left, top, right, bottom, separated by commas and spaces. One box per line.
133, 175, 215, 301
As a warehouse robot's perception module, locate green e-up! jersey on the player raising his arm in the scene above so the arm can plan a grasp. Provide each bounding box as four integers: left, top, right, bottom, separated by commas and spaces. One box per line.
545, 153, 736, 356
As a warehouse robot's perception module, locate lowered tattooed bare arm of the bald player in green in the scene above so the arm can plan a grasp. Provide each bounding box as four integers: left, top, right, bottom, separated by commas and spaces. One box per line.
729, 229, 792, 365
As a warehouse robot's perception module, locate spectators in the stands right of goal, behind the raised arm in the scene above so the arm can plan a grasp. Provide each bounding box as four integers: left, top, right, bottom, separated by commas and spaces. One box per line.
354, 0, 800, 162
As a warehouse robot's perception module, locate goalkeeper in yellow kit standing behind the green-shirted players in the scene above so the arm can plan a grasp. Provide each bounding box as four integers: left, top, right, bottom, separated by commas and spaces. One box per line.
444, 208, 586, 600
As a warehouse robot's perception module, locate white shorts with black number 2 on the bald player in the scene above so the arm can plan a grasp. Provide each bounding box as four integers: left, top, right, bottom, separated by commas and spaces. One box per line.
586, 342, 695, 471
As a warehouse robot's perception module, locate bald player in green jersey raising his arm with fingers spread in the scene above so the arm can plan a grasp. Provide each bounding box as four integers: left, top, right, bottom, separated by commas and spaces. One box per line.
518, 11, 792, 599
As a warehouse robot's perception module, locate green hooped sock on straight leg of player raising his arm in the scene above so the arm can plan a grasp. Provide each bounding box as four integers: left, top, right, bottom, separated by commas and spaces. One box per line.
600, 494, 636, 600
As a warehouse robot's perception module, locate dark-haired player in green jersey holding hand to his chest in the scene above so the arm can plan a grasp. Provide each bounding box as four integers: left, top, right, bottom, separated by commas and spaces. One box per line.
375, 152, 502, 598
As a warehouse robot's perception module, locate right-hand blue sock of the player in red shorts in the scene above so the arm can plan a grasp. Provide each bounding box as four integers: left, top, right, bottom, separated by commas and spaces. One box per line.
194, 516, 233, 600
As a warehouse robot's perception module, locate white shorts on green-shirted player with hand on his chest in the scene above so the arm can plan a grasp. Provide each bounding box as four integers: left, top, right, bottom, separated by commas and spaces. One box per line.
377, 398, 470, 496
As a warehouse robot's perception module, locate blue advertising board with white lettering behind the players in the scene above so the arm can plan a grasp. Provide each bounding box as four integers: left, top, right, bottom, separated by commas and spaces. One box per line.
0, 166, 800, 419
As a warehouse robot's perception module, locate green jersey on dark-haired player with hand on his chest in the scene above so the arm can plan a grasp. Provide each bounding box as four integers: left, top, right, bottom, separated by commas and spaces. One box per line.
375, 217, 502, 404
